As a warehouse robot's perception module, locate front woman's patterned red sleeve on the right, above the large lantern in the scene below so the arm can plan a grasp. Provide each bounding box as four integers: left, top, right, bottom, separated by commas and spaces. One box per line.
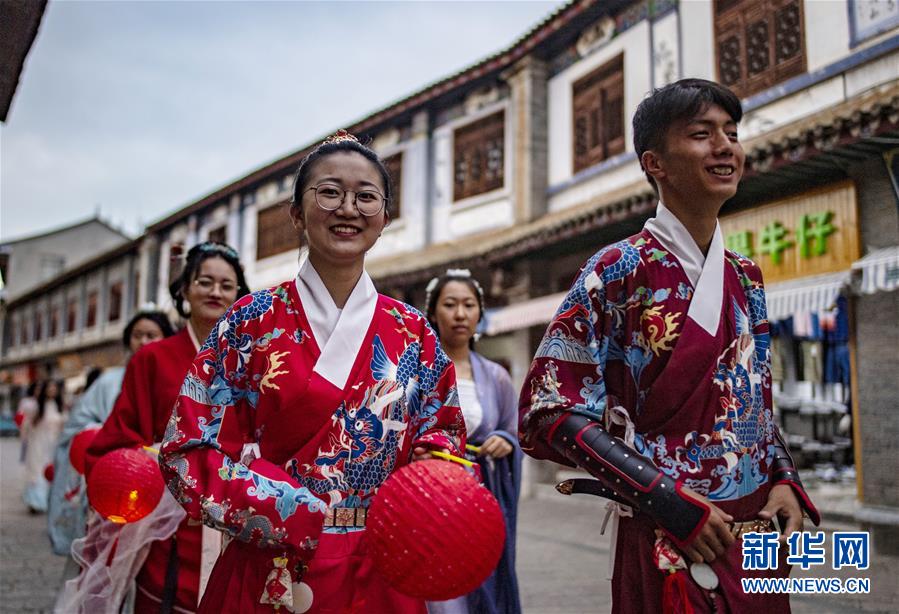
411, 318, 465, 456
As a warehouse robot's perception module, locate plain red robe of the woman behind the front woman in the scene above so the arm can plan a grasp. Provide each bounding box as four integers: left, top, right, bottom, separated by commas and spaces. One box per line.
86, 327, 202, 613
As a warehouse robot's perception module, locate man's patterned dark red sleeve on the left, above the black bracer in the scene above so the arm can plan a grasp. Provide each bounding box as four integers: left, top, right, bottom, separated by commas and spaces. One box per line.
518, 257, 609, 465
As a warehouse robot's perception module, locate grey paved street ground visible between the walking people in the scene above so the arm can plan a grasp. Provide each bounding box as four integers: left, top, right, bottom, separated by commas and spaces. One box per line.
0, 438, 899, 614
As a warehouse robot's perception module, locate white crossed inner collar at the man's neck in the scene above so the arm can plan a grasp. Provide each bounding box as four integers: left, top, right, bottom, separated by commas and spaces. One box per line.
644, 201, 724, 335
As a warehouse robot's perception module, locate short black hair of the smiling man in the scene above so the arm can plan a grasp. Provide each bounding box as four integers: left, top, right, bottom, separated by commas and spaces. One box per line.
633, 79, 743, 188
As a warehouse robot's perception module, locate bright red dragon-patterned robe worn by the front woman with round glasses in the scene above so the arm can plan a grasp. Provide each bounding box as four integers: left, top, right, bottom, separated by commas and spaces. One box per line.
161, 272, 465, 613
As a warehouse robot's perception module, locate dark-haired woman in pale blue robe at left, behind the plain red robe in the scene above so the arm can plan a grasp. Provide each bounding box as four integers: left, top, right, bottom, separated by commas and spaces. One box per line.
47, 309, 175, 556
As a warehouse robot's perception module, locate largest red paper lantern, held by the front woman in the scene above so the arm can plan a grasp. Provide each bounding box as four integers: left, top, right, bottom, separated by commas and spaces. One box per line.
365, 460, 506, 601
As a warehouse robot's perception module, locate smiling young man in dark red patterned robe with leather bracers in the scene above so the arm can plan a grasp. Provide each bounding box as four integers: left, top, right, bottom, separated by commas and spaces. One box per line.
520, 79, 818, 612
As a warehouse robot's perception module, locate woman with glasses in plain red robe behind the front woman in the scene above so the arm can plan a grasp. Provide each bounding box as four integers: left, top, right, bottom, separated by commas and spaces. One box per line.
86, 242, 249, 613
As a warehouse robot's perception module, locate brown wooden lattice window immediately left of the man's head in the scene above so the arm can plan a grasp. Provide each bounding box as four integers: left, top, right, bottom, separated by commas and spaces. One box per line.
571, 55, 624, 172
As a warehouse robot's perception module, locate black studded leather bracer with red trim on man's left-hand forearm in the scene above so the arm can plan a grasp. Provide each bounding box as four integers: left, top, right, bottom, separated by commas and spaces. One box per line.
547, 413, 711, 547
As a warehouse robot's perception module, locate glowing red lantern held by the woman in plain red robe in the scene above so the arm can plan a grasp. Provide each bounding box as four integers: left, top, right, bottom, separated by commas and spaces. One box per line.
87, 448, 165, 523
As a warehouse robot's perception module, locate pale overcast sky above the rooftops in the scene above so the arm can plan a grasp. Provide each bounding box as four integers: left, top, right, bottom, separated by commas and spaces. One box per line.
0, 0, 564, 239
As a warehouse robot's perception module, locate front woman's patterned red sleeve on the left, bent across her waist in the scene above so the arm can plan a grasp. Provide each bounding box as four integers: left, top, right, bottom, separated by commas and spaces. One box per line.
159, 295, 327, 560
